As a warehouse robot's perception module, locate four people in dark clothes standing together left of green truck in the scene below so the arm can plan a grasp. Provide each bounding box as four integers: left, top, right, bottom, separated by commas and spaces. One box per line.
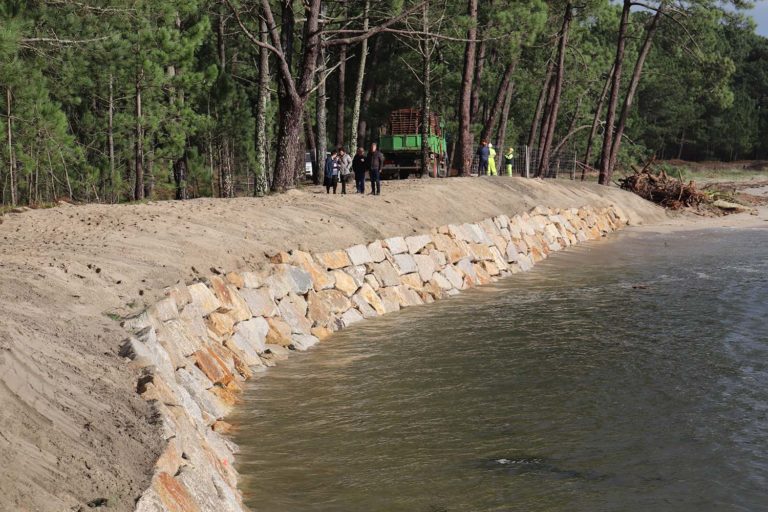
323, 143, 384, 196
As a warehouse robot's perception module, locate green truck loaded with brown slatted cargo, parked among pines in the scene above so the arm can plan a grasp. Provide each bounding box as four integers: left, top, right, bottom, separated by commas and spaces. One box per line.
379, 108, 448, 179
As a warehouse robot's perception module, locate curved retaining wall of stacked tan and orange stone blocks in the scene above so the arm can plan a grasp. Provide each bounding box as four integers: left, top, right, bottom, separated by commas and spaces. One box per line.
121, 206, 628, 512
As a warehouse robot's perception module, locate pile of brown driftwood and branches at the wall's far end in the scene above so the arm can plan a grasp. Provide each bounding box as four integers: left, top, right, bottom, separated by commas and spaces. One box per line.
619, 161, 707, 210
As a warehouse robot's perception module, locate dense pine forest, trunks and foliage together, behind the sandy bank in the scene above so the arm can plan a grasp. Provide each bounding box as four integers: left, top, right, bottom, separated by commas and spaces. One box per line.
0, 0, 768, 205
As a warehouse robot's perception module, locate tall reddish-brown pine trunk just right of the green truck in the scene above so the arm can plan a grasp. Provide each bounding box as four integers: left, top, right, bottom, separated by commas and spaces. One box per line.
453, 0, 477, 176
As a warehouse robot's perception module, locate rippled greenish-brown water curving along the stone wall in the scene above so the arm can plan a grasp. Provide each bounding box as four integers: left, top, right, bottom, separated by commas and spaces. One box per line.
236, 229, 768, 512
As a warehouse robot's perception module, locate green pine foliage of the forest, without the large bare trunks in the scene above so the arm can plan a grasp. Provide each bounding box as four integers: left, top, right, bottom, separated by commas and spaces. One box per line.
0, 0, 768, 204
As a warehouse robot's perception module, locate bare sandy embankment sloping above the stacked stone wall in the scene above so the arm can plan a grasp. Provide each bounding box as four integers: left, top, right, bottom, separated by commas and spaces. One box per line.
0, 178, 666, 510
